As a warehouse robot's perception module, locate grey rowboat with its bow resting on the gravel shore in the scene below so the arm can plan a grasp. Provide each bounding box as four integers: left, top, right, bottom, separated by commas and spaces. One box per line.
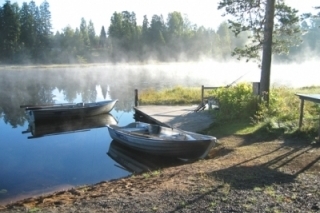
107, 122, 217, 159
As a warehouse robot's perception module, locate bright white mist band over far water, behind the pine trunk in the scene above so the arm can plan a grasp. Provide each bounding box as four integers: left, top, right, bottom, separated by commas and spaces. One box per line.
103, 60, 320, 88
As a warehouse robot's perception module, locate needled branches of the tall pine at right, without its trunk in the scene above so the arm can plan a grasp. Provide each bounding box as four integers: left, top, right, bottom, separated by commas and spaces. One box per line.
218, 0, 302, 61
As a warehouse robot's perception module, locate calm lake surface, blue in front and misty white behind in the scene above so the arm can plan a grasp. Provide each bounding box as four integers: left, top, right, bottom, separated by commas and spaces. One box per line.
0, 62, 319, 204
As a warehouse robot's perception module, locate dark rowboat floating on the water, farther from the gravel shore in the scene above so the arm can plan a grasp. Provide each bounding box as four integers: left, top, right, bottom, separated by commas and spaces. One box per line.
25, 99, 118, 122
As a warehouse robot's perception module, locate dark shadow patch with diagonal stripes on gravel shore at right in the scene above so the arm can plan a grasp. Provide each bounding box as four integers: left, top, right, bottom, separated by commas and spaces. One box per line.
209, 147, 320, 189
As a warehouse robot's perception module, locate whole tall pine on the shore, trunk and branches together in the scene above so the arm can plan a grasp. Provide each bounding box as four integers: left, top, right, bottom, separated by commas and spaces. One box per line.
218, 0, 301, 103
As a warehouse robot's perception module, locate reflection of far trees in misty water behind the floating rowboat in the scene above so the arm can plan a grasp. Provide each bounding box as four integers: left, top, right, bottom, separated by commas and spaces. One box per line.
0, 66, 194, 127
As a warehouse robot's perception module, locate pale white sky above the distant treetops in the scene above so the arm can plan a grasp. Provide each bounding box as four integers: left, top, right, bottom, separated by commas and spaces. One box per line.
5, 0, 320, 34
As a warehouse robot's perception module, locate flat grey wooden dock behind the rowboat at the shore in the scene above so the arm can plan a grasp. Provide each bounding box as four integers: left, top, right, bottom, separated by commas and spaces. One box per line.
134, 105, 214, 132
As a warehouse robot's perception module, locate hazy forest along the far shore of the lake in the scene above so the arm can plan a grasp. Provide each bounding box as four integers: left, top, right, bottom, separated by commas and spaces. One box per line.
0, 0, 320, 65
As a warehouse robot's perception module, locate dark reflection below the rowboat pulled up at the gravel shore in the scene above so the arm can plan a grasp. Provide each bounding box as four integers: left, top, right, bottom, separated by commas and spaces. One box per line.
107, 140, 187, 174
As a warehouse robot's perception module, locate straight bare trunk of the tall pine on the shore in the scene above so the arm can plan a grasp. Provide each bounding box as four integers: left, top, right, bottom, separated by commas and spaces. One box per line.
260, 0, 275, 103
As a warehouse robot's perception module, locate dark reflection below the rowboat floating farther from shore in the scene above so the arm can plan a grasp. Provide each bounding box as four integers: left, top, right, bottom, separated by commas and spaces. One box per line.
22, 113, 118, 139
